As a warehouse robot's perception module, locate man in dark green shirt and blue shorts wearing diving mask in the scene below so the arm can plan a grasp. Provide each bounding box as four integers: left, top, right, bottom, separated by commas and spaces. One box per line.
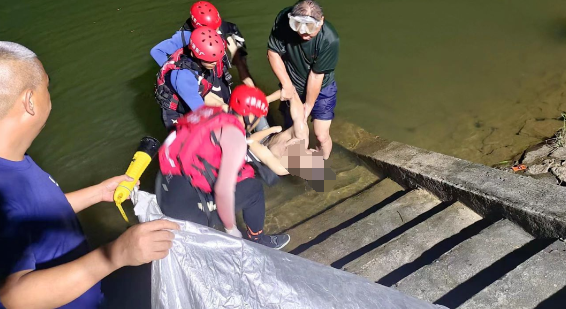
267, 0, 340, 159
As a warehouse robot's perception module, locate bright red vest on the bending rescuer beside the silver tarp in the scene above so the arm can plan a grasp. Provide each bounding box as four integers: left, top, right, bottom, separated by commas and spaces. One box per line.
159, 106, 254, 193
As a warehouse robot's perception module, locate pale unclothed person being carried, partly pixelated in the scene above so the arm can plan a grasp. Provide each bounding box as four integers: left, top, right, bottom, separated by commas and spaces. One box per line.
248, 126, 336, 192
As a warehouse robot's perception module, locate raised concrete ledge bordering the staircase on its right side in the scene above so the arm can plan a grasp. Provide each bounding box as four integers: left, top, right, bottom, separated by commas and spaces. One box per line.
355, 140, 566, 238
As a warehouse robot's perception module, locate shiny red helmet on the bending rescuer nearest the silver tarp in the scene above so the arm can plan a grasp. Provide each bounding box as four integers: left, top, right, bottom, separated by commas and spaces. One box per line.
230, 85, 269, 117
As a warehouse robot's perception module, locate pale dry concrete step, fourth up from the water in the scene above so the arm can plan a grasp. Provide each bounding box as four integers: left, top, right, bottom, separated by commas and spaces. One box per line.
395, 220, 533, 308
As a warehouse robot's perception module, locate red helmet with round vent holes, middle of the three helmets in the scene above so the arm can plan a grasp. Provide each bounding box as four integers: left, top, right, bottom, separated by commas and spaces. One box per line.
189, 27, 226, 62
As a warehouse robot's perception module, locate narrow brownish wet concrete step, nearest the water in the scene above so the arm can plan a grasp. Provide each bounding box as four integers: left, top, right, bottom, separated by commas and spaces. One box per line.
285, 179, 404, 253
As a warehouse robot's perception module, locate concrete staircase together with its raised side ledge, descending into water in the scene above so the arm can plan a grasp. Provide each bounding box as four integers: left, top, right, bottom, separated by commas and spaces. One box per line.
267, 119, 566, 309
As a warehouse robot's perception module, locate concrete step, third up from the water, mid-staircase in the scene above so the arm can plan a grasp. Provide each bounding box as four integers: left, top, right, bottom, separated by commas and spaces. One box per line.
344, 202, 489, 286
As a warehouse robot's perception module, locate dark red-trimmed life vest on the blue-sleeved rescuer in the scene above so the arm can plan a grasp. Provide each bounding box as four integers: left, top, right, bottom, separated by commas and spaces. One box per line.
155, 48, 230, 113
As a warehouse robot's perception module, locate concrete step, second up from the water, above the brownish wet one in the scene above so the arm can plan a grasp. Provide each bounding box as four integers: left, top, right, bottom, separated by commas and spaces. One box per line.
300, 190, 440, 265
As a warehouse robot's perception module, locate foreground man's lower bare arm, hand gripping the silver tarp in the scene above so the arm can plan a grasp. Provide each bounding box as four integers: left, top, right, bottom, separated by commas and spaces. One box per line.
0, 220, 179, 309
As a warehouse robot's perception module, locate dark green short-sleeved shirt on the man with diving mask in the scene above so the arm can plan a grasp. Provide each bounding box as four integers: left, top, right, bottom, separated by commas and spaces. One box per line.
267, 7, 340, 95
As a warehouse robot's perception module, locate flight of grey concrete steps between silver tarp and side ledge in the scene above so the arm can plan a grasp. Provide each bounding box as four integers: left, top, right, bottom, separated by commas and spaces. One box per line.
288, 179, 566, 308
